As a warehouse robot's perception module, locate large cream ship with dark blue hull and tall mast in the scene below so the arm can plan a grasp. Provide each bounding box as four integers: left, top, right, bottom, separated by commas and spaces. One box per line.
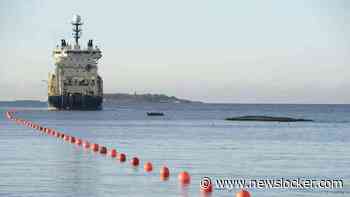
48, 15, 103, 110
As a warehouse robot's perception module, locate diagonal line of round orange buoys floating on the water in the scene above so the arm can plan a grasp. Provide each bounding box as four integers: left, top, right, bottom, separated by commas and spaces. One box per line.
5, 111, 251, 197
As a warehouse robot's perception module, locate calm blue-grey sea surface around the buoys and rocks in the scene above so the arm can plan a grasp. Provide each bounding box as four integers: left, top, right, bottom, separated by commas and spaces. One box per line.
0, 104, 350, 197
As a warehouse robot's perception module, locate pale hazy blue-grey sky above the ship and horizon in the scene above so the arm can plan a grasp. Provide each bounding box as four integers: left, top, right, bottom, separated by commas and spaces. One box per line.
0, 0, 350, 103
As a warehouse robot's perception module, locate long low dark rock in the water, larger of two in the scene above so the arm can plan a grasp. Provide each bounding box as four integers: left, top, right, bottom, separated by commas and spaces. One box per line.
225, 116, 313, 122
